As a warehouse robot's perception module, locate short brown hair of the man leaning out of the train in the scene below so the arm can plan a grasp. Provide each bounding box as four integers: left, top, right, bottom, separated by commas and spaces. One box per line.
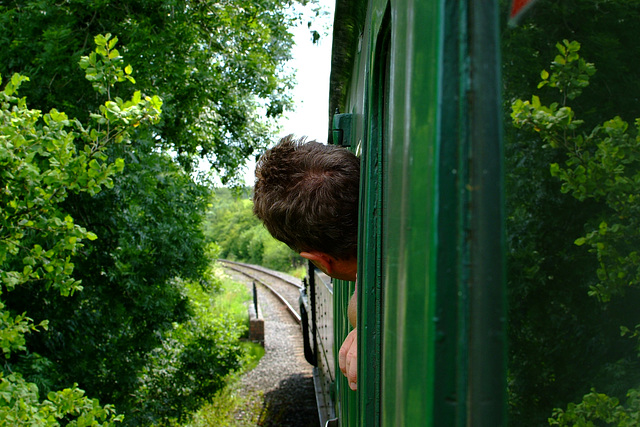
253, 135, 360, 259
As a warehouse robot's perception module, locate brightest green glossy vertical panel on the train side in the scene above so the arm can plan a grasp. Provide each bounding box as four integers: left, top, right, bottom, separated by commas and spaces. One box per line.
381, 0, 441, 426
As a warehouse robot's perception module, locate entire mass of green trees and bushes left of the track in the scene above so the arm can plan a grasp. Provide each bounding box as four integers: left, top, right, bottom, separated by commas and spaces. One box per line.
0, 0, 312, 426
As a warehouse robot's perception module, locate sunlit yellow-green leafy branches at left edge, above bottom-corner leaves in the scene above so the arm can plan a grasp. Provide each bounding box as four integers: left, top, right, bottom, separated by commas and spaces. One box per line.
0, 37, 162, 296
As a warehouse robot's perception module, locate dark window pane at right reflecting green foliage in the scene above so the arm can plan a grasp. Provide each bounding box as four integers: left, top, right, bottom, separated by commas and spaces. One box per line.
501, 0, 640, 426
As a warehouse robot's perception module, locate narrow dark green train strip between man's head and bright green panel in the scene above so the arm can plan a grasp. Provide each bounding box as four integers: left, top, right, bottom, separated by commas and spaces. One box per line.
357, 2, 391, 426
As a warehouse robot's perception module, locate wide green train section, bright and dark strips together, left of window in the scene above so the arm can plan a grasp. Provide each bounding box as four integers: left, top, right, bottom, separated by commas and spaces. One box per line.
380, 0, 506, 427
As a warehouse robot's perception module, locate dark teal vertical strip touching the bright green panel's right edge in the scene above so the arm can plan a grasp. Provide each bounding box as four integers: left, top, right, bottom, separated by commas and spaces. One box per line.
433, 1, 469, 427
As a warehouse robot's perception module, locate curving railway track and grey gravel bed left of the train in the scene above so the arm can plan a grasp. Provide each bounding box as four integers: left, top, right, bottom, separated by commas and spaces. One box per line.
218, 260, 320, 427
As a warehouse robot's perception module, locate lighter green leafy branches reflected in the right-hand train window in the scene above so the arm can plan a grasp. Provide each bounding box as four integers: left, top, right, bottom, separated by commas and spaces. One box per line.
512, 40, 640, 425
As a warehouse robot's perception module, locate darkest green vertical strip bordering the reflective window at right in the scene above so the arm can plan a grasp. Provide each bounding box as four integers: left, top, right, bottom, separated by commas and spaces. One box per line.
467, 0, 507, 427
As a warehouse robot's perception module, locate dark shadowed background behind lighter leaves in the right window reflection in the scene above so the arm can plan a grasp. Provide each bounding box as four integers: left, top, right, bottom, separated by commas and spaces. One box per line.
502, 0, 640, 425
